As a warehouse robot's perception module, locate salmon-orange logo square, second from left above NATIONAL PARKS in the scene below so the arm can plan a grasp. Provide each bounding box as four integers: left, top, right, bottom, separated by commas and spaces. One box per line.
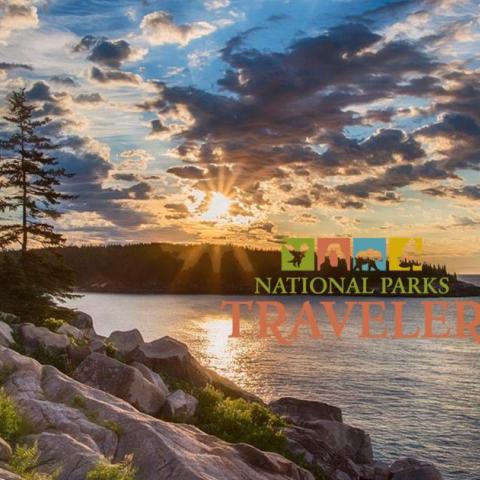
317, 237, 352, 274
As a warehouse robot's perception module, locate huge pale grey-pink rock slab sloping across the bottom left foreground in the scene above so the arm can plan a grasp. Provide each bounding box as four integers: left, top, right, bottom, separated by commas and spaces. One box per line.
0, 347, 314, 480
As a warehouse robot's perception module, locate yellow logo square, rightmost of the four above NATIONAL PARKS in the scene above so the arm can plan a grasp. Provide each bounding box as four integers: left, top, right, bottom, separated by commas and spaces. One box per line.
388, 237, 423, 272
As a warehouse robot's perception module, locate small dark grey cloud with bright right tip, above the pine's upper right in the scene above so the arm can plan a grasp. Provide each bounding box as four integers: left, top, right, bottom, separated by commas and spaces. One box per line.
73, 35, 148, 68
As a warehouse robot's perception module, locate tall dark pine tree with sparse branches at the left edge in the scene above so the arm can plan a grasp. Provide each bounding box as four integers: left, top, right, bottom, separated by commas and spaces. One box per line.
0, 89, 73, 320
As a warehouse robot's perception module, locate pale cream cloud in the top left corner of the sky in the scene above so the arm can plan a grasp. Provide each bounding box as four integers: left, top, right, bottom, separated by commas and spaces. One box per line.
0, 0, 38, 41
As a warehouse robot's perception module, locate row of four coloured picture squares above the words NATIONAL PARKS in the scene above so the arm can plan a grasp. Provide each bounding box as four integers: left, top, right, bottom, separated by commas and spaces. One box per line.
281, 237, 423, 275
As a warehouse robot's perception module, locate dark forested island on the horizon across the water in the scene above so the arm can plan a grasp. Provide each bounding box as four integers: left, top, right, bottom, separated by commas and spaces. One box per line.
44, 243, 480, 297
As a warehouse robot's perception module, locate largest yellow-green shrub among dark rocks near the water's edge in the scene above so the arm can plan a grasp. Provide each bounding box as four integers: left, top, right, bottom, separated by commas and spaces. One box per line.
195, 386, 286, 454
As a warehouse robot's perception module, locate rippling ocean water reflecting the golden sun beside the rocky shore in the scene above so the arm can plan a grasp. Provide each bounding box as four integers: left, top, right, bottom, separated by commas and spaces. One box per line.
67, 294, 480, 480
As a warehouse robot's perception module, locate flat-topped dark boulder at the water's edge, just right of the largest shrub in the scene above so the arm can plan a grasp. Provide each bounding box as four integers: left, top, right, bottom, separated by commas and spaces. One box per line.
269, 397, 342, 425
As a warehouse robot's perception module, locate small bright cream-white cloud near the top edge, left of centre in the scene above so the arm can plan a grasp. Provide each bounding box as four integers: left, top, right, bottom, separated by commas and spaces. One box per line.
140, 11, 217, 47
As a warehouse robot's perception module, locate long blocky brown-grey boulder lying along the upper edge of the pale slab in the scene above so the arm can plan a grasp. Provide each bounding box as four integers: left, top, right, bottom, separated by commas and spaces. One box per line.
73, 353, 166, 415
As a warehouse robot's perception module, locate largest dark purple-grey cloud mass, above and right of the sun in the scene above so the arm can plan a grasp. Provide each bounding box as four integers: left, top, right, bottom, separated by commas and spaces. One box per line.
140, 20, 439, 208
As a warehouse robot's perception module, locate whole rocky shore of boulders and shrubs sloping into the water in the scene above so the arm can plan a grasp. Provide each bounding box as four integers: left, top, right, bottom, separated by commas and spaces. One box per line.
0, 312, 442, 480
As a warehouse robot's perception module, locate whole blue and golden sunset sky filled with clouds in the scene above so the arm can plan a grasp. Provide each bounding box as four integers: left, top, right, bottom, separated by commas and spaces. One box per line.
0, 0, 480, 273
